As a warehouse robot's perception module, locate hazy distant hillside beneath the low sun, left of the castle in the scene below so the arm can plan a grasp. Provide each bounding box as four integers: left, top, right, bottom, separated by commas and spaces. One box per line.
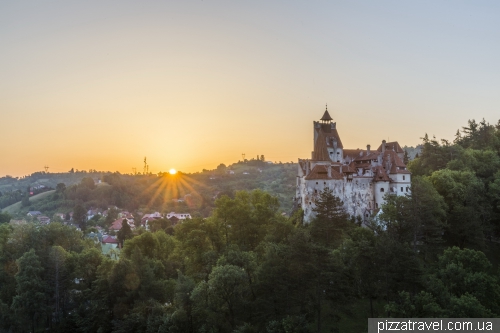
0, 160, 297, 217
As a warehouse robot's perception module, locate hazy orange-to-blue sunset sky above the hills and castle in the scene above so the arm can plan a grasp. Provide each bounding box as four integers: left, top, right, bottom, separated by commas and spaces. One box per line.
0, 0, 500, 176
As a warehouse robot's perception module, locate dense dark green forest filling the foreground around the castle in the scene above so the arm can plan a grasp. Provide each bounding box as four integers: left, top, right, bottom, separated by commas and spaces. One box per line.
0, 120, 500, 333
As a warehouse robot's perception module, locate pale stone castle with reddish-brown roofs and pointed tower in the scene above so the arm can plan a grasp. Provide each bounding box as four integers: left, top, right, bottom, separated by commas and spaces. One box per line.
295, 110, 411, 222
